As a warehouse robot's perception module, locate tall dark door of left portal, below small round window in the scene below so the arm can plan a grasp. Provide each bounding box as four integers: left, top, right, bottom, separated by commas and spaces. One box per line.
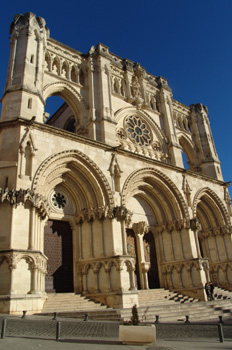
44, 220, 73, 293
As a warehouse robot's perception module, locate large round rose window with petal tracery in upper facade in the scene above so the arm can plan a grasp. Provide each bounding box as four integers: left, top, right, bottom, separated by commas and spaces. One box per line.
125, 116, 151, 146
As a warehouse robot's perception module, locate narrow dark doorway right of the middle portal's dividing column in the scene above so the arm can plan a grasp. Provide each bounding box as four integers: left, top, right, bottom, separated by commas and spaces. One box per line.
143, 232, 160, 289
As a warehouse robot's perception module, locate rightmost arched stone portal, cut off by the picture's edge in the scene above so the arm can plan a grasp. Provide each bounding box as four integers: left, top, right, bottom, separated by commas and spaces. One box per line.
194, 188, 232, 288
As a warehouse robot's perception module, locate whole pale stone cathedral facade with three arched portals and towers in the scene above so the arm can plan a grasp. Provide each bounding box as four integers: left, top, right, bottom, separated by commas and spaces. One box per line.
0, 13, 232, 314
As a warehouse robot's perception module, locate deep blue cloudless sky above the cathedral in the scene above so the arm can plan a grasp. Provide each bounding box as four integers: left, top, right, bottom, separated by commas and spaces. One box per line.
0, 0, 232, 193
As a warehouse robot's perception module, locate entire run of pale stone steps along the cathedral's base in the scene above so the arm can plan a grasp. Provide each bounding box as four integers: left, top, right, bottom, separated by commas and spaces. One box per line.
37, 288, 232, 323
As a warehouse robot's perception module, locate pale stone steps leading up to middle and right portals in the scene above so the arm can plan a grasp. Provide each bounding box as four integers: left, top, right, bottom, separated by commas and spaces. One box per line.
120, 288, 232, 323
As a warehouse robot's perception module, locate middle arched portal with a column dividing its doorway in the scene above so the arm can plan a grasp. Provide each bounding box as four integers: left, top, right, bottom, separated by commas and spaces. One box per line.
122, 168, 192, 289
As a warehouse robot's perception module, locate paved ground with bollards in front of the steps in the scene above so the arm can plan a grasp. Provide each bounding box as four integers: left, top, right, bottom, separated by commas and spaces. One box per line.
0, 316, 232, 350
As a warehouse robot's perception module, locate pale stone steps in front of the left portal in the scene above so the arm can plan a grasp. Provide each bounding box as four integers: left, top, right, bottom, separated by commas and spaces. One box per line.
37, 293, 120, 321
